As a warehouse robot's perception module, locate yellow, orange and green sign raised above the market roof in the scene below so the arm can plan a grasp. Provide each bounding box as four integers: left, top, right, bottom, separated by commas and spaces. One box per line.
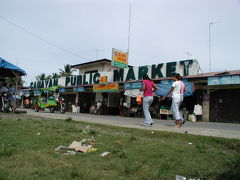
112, 49, 128, 68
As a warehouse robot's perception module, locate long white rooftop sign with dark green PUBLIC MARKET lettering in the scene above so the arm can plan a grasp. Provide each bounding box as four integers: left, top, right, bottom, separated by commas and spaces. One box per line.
30, 59, 199, 89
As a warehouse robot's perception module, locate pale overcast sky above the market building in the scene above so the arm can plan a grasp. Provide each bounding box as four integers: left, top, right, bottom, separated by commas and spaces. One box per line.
0, 0, 240, 83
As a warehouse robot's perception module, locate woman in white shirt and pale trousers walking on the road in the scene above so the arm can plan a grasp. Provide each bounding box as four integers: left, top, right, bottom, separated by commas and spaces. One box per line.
163, 73, 181, 128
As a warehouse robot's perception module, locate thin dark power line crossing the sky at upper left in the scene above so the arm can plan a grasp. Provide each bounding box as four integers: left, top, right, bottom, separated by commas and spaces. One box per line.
0, 15, 89, 60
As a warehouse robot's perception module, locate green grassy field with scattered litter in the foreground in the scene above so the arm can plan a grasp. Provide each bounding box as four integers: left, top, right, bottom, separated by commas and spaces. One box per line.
0, 116, 240, 180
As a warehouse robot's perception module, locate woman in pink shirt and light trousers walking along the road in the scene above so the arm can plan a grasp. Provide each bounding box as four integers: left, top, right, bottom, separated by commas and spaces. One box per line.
141, 75, 158, 126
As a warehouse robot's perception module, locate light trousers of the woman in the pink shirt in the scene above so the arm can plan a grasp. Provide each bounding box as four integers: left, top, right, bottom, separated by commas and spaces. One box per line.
143, 96, 153, 125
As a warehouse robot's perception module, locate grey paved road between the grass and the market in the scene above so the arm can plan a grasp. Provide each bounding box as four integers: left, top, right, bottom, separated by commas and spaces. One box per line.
15, 110, 240, 139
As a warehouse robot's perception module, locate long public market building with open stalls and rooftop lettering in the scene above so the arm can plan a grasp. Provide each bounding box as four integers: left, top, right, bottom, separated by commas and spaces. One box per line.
30, 59, 240, 122
